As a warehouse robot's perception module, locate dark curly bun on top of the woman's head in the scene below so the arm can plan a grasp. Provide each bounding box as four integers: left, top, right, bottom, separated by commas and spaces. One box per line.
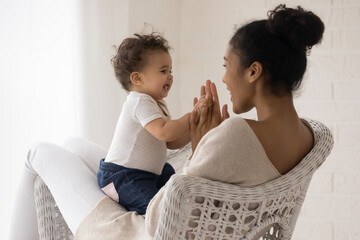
267, 4, 324, 53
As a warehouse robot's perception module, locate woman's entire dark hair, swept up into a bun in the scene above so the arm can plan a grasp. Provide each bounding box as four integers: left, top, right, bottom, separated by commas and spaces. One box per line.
230, 4, 324, 96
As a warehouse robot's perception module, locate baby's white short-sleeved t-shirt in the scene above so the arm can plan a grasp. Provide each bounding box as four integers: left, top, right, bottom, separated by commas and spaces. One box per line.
105, 91, 170, 175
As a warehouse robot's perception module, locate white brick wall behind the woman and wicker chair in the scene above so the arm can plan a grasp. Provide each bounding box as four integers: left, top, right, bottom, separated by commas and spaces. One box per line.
124, 0, 360, 240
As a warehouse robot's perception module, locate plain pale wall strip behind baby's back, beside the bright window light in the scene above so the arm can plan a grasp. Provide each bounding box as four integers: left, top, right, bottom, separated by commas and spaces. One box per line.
74, 0, 129, 147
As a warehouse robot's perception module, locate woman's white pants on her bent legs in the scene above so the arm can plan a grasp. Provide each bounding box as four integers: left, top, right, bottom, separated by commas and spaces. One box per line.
10, 138, 106, 240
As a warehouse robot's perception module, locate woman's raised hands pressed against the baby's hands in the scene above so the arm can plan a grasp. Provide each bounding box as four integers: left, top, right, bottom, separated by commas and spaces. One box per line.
190, 80, 229, 152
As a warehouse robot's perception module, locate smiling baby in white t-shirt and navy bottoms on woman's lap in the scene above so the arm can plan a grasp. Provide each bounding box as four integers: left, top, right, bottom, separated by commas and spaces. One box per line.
98, 33, 194, 215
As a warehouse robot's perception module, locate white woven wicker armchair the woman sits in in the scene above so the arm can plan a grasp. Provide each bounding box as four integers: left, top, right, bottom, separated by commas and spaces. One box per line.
35, 120, 333, 240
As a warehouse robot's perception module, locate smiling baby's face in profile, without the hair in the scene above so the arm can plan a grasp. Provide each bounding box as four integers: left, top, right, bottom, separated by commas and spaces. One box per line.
140, 50, 173, 100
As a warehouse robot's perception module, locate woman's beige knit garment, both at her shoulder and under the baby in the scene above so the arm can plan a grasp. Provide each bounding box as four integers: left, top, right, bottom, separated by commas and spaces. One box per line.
76, 117, 280, 239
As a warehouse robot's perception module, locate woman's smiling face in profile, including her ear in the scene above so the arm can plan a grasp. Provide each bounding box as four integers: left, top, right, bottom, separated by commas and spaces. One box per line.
222, 45, 255, 114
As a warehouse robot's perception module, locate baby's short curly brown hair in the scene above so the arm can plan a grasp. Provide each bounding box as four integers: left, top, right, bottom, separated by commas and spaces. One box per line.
111, 32, 171, 91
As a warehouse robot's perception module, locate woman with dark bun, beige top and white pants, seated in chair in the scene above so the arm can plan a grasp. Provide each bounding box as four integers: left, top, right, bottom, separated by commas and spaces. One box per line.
11, 5, 324, 239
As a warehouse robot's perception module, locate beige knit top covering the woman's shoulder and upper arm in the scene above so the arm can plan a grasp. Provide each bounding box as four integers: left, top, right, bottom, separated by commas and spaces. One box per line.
184, 117, 280, 186
